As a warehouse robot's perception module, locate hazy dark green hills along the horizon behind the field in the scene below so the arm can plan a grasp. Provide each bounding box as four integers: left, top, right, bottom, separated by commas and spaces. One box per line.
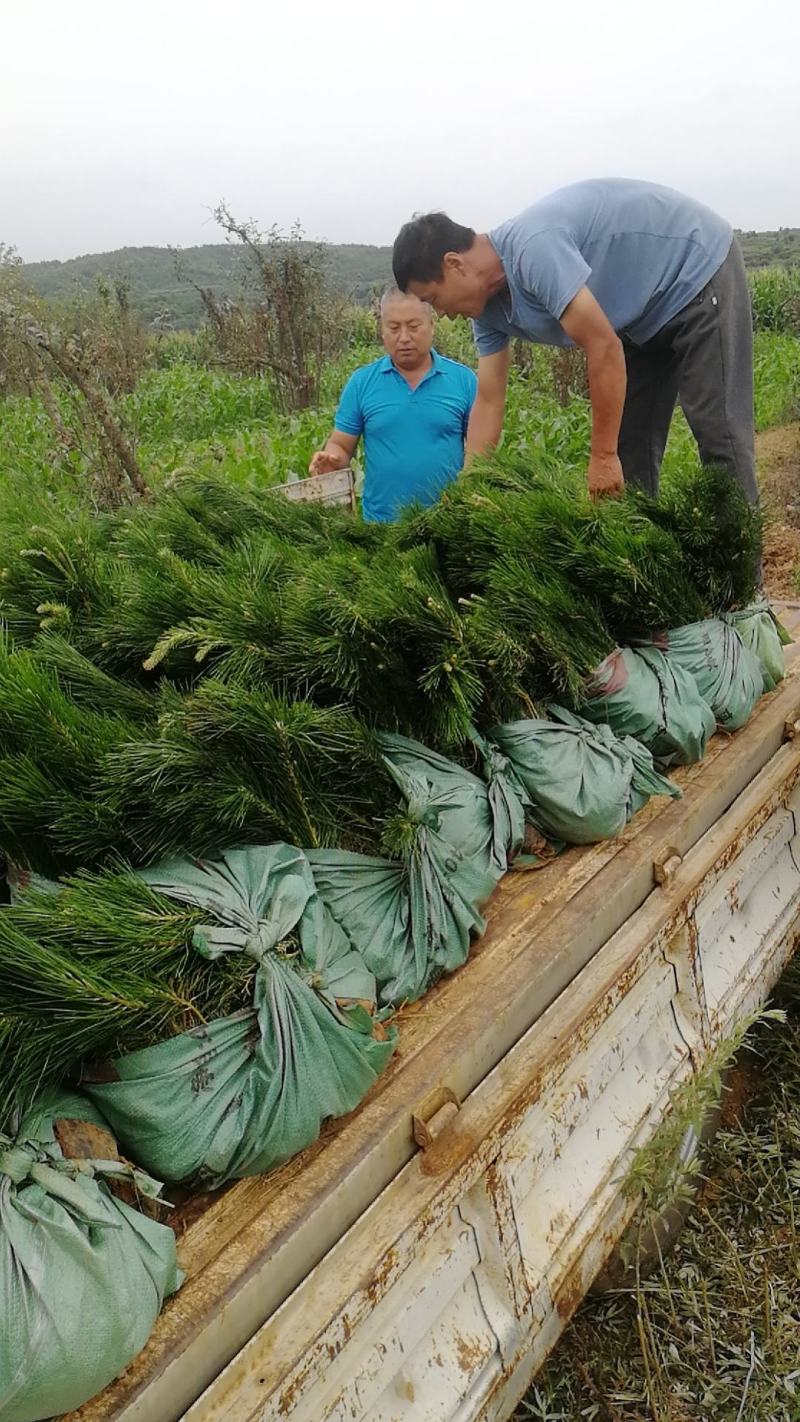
24, 228, 800, 327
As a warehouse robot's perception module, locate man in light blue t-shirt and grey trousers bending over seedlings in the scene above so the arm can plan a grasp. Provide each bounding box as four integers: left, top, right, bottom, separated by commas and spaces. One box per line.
394, 178, 757, 502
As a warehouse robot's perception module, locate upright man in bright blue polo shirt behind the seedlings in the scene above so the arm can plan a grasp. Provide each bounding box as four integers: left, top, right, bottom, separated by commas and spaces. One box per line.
308, 287, 477, 523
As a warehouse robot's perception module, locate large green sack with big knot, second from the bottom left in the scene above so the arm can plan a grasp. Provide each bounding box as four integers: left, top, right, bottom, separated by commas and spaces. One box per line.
85, 845, 396, 1186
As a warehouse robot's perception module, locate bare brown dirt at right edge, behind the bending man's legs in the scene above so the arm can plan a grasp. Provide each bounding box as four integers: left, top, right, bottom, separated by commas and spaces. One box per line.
756, 424, 800, 599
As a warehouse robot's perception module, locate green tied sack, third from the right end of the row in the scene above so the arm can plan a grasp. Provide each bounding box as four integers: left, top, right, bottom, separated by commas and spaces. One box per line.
581, 646, 716, 766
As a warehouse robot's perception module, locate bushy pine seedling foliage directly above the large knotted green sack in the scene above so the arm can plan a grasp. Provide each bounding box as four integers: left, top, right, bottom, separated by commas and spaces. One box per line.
92, 678, 389, 865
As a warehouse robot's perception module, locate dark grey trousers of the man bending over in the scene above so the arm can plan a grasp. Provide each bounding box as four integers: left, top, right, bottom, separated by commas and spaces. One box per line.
620, 239, 759, 503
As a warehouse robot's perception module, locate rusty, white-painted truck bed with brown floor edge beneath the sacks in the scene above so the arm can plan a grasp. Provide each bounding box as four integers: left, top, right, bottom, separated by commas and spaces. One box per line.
71, 622, 800, 1422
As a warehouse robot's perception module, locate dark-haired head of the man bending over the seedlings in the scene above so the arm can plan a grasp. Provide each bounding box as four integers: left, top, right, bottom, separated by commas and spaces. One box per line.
392, 212, 492, 316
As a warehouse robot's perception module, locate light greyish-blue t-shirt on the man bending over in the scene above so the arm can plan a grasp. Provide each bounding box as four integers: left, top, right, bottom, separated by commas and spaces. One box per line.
473, 178, 733, 356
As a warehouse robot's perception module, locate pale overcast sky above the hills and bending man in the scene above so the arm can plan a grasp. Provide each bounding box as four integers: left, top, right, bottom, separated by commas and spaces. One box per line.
6, 0, 800, 260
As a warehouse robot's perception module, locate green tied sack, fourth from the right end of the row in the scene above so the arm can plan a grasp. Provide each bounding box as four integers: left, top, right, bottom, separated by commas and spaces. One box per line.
489, 707, 681, 845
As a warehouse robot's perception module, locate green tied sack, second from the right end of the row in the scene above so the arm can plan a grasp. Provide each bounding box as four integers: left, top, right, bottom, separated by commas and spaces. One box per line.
654, 617, 763, 731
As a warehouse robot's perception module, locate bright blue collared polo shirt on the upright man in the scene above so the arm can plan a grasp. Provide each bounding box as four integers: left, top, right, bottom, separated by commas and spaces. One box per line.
334, 351, 477, 523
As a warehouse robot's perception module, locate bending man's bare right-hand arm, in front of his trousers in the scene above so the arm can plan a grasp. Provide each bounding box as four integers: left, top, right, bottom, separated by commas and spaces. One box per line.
561, 286, 627, 498
